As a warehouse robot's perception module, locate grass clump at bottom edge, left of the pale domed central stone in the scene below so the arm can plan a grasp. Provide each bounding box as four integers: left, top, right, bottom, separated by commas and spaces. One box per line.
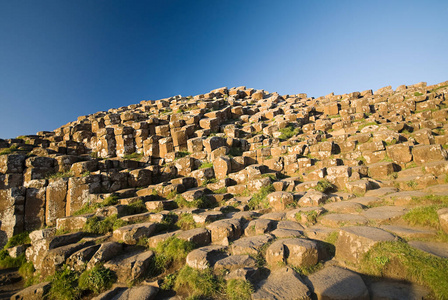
174, 266, 222, 299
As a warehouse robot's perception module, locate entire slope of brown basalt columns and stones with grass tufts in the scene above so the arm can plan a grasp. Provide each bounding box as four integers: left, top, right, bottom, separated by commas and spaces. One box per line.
0, 82, 448, 299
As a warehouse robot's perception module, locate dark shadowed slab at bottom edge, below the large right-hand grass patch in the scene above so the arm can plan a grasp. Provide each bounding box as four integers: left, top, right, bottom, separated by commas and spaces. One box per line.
369, 281, 431, 300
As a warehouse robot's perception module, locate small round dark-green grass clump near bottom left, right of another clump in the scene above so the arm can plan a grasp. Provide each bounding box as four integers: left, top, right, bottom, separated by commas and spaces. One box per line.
79, 264, 117, 294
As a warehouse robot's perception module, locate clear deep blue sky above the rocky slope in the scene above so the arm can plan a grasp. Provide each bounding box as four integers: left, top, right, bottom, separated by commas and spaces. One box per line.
0, 0, 448, 138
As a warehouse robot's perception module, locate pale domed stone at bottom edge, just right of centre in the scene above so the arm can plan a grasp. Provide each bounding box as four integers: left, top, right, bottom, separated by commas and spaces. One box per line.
252, 268, 311, 300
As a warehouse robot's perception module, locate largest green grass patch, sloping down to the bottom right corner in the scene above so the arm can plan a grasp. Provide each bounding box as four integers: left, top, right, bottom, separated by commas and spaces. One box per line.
360, 242, 448, 299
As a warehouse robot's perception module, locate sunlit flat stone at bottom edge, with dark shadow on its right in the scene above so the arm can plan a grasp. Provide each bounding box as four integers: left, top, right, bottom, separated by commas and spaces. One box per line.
308, 267, 370, 300
